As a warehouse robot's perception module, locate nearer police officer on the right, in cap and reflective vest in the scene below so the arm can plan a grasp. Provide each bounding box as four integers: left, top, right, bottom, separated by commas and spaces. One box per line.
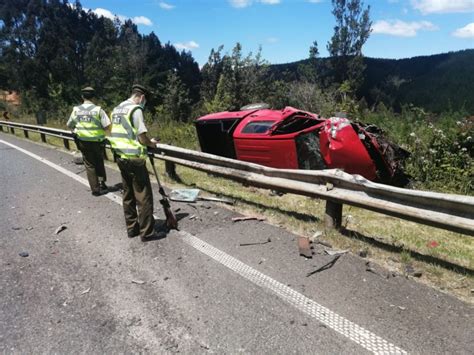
109, 85, 157, 240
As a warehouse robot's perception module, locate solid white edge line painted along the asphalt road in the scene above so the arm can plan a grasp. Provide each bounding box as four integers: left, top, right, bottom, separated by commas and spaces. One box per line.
0, 140, 407, 354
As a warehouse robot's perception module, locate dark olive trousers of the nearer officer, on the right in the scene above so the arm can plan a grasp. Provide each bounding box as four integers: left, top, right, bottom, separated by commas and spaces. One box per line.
117, 158, 155, 238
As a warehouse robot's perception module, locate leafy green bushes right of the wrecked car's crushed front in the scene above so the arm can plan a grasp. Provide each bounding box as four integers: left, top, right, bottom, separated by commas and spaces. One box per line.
367, 106, 474, 195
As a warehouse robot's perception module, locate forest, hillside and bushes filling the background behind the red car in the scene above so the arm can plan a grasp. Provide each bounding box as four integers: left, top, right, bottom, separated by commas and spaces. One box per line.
0, 0, 474, 194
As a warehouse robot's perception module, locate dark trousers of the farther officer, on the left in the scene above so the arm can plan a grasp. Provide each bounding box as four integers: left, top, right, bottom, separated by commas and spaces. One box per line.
76, 140, 107, 192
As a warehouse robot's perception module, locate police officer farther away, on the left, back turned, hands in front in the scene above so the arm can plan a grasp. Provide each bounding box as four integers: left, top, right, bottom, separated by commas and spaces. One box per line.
67, 87, 110, 196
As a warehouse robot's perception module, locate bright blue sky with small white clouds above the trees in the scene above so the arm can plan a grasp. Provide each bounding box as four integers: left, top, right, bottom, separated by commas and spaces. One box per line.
78, 0, 474, 65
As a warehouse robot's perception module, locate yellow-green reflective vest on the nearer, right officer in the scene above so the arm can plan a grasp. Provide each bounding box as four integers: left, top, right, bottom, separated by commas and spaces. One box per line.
109, 102, 147, 159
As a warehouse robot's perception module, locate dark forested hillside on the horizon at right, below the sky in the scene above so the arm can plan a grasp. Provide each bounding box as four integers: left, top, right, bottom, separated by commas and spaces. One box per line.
271, 49, 474, 114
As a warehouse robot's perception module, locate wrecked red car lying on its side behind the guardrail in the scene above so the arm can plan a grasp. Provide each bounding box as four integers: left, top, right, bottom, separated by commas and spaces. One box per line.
195, 105, 409, 186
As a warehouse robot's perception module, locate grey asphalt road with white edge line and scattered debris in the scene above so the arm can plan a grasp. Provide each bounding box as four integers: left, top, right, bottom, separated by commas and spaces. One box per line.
0, 133, 474, 354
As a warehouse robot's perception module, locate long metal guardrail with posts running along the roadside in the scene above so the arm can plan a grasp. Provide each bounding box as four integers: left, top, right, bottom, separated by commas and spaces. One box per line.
0, 121, 474, 236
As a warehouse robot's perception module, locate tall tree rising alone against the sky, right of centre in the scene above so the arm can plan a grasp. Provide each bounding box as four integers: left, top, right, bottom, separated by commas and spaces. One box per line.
327, 0, 372, 92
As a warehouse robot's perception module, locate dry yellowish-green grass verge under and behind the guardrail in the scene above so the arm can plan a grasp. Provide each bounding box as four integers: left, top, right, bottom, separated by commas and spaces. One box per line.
3, 116, 474, 303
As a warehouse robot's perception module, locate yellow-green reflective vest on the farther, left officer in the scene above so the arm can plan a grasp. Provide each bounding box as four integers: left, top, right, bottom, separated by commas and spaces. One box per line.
72, 104, 105, 142
